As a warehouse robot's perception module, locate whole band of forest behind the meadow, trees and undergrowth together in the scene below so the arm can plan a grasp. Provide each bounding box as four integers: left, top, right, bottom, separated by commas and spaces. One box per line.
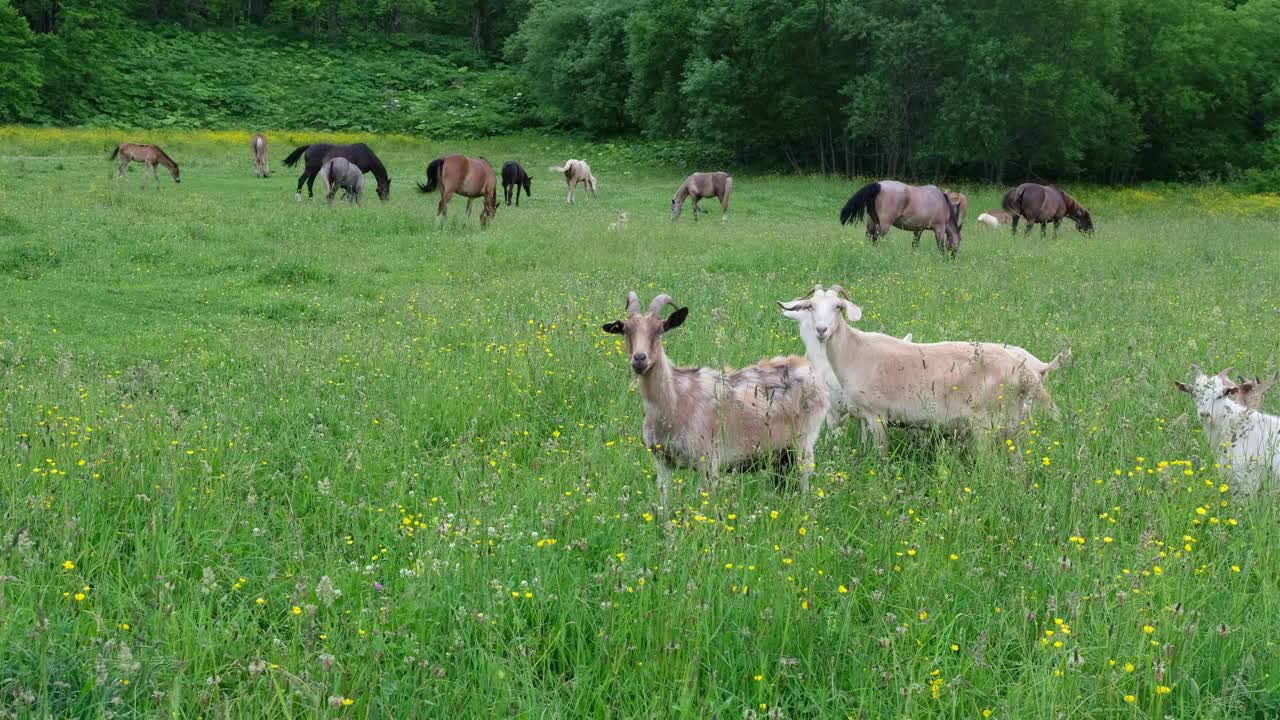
0, 0, 1280, 183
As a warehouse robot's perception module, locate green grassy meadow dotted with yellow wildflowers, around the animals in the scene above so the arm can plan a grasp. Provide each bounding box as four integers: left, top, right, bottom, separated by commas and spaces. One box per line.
0, 128, 1280, 720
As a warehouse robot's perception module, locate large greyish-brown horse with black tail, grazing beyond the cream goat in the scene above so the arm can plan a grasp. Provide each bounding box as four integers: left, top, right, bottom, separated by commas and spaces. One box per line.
840, 181, 960, 258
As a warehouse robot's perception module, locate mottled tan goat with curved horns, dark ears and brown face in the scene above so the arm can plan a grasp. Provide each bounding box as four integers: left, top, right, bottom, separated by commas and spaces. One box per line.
603, 292, 828, 507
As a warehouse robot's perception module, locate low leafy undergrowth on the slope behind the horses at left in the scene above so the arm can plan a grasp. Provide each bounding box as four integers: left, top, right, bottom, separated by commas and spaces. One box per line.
27, 31, 527, 137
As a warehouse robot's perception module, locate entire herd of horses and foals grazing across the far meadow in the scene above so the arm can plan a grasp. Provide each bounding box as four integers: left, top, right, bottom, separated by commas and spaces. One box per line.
111, 133, 1093, 249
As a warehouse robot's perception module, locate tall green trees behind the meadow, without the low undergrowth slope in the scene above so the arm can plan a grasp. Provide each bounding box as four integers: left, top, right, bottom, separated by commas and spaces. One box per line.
0, 0, 1280, 183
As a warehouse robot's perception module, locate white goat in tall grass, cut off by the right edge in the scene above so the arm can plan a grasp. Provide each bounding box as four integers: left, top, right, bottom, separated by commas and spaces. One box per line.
1174, 365, 1280, 495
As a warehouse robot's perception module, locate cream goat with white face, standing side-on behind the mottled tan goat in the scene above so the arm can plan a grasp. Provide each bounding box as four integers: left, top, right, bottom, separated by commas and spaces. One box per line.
778, 286, 1069, 455
